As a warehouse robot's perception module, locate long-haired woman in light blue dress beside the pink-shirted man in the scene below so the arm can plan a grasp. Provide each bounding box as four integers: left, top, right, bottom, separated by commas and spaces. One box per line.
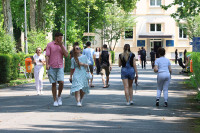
69, 42, 89, 107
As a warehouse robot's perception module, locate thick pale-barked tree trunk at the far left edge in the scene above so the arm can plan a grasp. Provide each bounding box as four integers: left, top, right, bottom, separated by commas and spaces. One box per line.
2, 0, 13, 38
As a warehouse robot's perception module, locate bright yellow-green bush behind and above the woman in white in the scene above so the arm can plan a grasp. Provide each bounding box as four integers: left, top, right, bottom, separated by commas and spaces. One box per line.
28, 31, 48, 54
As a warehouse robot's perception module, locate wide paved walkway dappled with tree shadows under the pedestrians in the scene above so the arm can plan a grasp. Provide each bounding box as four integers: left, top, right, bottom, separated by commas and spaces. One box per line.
0, 65, 200, 133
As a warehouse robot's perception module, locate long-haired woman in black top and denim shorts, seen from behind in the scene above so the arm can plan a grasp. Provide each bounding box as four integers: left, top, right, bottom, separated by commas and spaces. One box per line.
118, 44, 138, 105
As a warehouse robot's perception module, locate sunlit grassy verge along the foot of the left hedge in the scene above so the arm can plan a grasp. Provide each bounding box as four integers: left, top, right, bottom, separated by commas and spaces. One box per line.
0, 73, 35, 88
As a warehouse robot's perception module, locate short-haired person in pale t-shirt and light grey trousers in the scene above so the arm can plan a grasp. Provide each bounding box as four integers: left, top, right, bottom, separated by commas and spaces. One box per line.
154, 48, 172, 107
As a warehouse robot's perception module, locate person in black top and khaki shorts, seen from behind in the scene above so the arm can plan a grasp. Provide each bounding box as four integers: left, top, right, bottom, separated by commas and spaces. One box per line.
99, 44, 112, 88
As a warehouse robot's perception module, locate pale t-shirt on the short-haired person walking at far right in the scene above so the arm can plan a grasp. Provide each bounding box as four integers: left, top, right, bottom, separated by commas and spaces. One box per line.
155, 57, 171, 73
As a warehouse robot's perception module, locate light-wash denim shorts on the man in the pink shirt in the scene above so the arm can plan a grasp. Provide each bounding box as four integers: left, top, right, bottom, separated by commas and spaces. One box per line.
48, 67, 64, 83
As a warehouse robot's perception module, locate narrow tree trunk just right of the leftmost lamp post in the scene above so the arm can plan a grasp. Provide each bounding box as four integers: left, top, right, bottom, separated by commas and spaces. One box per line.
30, 0, 36, 30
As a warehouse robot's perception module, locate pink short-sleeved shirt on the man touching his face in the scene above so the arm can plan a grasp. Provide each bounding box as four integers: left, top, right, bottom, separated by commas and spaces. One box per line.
46, 41, 66, 68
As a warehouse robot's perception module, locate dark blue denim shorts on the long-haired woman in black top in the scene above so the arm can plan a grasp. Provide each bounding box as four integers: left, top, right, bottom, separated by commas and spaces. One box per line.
121, 67, 135, 80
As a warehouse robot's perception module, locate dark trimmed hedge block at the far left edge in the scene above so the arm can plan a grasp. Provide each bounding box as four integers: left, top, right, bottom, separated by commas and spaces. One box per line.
0, 54, 12, 83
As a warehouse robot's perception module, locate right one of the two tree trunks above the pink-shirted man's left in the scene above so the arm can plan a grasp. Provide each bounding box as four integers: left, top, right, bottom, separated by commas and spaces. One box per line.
37, 0, 46, 30
